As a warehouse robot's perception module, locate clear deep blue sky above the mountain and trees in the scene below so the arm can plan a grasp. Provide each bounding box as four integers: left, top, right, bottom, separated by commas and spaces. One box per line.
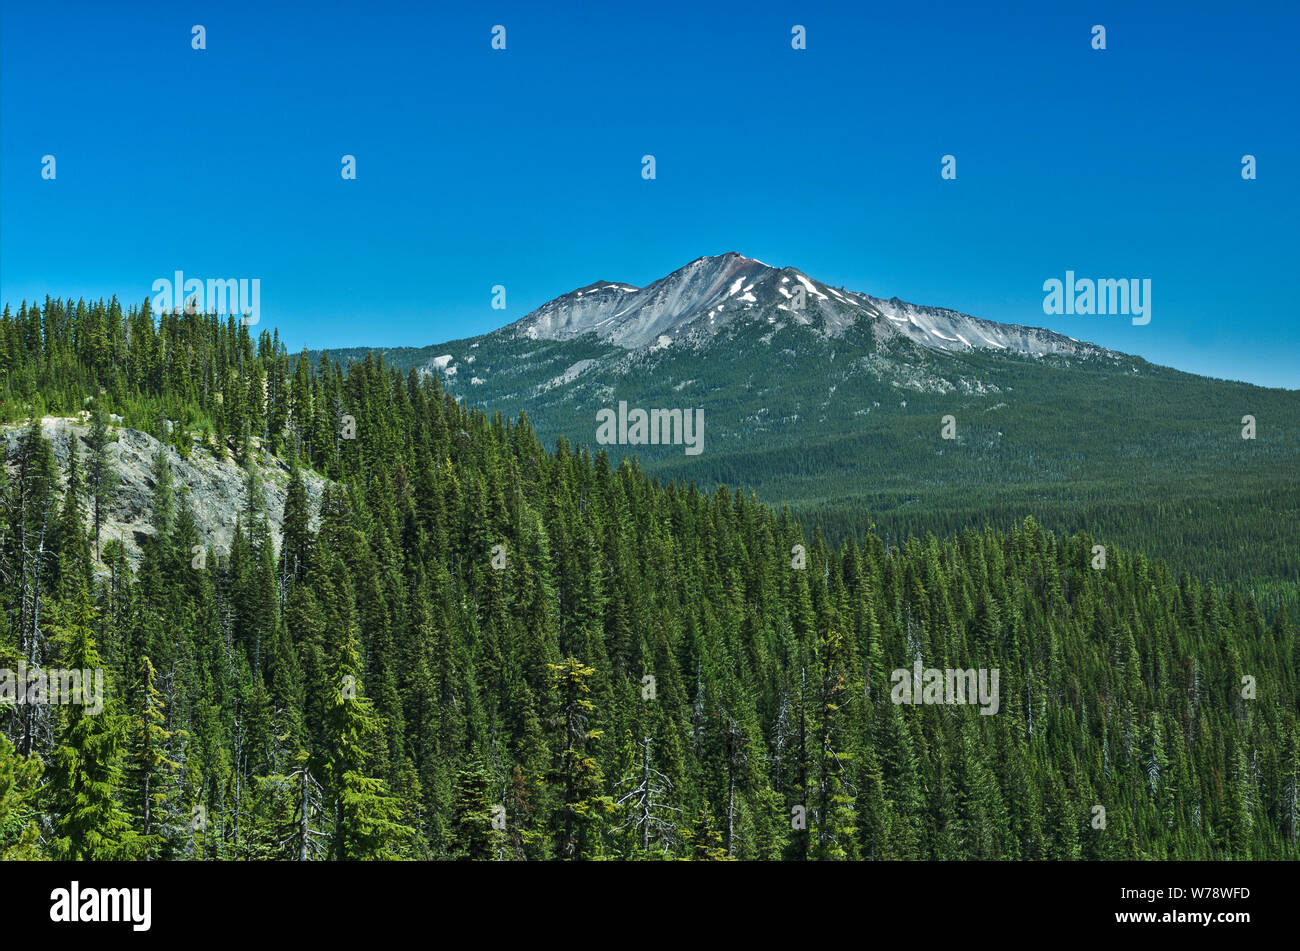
0, 0, 1300, 388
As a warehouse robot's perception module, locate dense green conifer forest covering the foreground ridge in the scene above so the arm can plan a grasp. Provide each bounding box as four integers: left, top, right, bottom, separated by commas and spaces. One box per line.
0, 300, 1300, 860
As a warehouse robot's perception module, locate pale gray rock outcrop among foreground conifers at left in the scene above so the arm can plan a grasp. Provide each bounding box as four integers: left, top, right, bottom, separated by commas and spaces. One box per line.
0, 416, 325, 564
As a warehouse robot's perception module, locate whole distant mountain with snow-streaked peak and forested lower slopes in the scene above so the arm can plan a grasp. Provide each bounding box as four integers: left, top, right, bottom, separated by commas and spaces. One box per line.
319, 253, 1300, 595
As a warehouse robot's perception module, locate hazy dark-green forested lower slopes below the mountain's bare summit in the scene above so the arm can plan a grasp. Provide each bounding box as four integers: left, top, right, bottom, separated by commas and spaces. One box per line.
364, 293, 1300, 597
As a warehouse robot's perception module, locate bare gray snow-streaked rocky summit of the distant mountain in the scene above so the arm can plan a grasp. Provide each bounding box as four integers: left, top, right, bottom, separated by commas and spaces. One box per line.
498, 252, 1117, 357
